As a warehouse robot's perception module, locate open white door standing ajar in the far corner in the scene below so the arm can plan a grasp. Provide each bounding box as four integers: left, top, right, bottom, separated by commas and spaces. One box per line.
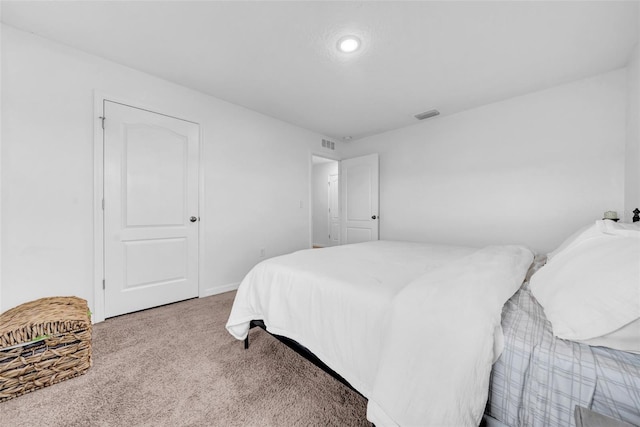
340, 153, 379, 244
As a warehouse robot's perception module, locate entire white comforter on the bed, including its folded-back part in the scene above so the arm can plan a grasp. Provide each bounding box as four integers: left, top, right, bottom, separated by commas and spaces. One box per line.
227, 241, 532, 426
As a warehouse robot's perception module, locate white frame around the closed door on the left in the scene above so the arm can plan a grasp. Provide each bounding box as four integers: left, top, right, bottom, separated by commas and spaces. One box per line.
91, 90, 206, 323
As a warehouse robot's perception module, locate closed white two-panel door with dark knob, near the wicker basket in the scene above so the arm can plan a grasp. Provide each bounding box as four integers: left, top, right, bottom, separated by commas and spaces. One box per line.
104, 101, 199, 317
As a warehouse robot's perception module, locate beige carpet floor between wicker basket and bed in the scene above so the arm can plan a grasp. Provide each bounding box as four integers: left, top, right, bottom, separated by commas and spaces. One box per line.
0, 292, 370, 427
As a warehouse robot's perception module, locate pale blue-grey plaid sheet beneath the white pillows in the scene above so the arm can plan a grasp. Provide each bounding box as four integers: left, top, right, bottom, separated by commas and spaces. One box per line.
486, 283, 640, 426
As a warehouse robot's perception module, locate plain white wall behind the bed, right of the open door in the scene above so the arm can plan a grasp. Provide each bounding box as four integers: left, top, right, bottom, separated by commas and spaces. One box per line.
344, 69, 626, 252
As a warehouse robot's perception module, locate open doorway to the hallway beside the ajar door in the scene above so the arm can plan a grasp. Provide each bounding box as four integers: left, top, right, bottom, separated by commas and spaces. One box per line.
311, 155, 340, 248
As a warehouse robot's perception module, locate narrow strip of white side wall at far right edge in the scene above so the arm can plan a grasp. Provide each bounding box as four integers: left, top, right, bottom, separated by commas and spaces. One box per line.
624, 40, 640, 221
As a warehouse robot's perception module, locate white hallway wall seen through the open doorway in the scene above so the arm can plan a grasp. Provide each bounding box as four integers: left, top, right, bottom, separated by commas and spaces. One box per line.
311, 161, 338, 246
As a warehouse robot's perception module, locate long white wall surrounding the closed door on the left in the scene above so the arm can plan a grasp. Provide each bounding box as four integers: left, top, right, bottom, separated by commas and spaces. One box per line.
0, 25, 339, 311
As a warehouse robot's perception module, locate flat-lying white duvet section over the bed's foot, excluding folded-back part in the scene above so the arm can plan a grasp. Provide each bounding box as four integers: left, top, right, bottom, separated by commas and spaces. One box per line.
227, 241, 475, 397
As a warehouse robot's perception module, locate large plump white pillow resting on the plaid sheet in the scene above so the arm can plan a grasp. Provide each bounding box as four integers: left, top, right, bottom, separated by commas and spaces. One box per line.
530, 220, 640, 351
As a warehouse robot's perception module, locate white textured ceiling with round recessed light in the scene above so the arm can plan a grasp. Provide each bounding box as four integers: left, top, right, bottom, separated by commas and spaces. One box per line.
2, 1, 638, 139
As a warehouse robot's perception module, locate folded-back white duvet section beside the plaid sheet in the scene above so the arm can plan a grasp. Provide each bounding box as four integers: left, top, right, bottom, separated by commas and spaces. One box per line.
367, 246, 533, 427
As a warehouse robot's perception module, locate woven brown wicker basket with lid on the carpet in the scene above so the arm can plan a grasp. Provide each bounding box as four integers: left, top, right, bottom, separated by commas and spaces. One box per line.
0, 297, 92, 402
